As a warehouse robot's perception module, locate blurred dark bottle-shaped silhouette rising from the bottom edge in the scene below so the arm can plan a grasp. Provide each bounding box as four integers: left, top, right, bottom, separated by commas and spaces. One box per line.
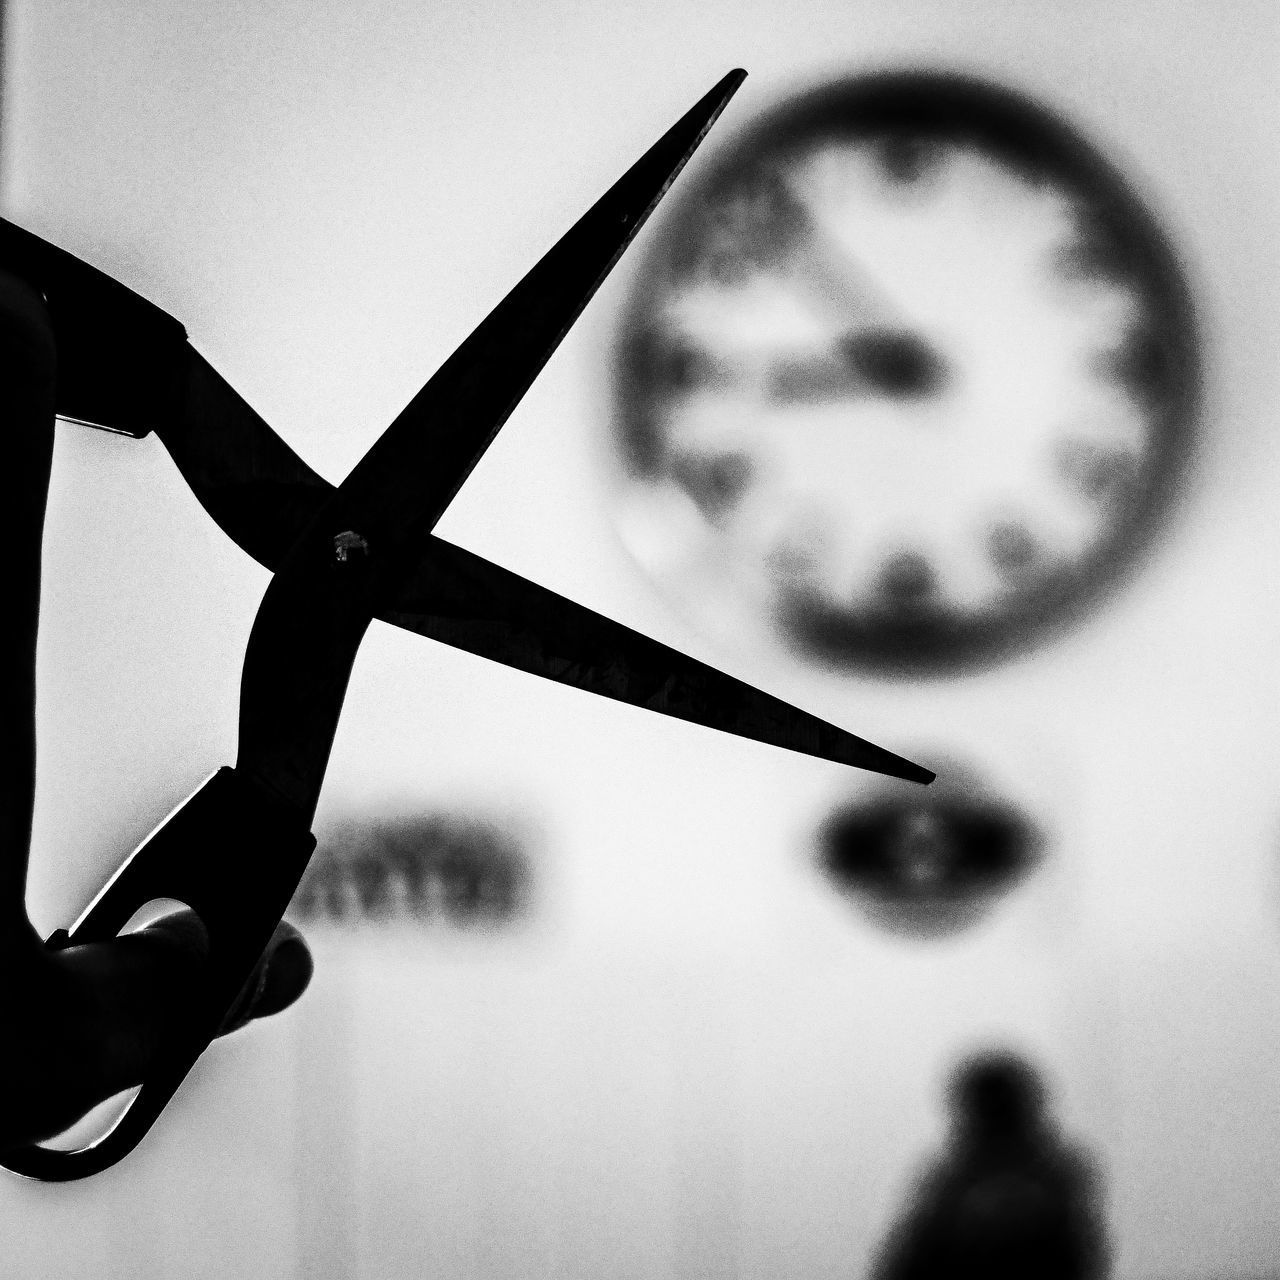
872, 1051, 1107, 1280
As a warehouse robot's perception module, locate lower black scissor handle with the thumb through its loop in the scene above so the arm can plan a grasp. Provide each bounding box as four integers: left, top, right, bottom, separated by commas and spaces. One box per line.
0, 768, 315, 1181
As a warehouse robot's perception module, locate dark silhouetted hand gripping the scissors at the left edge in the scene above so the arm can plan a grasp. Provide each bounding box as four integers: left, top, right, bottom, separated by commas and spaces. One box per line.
0, 268, 311, 1149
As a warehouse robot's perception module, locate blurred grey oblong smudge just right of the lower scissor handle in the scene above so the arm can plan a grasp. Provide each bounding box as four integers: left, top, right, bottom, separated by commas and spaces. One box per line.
292, 813, 530, 928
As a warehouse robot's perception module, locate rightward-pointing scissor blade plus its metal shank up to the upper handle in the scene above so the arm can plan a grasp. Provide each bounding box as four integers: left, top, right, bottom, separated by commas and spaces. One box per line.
149, 351, 932, 782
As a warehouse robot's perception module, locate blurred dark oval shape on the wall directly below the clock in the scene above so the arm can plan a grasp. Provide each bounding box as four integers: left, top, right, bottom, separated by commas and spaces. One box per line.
819, 768, 1042, 937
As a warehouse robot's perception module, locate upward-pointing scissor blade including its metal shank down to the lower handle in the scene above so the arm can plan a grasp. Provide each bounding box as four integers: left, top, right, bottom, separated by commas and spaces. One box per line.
237, 72, 745, 822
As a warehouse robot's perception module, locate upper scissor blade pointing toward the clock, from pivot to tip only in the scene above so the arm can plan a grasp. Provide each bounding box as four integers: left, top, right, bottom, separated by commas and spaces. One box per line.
320, 70, 746, 565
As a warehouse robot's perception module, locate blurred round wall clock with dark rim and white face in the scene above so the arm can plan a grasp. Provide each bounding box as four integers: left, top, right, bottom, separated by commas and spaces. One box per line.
616, 73, 1198, 671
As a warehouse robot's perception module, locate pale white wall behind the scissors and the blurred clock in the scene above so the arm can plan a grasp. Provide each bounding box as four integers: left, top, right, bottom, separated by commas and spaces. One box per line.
0, 0, 1280, 1280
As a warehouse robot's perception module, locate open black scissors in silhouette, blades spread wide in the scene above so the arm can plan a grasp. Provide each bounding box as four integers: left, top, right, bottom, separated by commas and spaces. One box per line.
0, 70, 933, 1181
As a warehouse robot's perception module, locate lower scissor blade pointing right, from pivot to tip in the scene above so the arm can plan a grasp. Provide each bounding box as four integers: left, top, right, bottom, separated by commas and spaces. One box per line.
380, 536, 933, 782
